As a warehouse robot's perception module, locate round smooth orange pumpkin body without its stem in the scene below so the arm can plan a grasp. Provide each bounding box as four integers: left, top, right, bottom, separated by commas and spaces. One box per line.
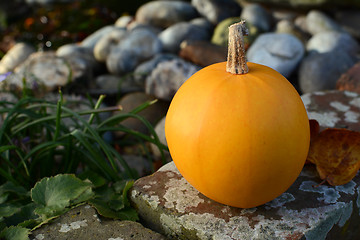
165, 62, 310, 208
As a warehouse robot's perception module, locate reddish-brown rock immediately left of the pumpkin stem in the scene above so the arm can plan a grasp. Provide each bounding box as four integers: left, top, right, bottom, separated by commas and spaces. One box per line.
179, 41, 227, 67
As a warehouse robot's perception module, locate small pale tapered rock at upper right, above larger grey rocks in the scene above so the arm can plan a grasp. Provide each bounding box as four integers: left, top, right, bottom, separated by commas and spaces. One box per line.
306, 10, 343, 35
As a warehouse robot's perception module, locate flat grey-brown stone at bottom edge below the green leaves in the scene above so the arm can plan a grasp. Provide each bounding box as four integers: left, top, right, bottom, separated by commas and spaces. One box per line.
30, 205, 166, 240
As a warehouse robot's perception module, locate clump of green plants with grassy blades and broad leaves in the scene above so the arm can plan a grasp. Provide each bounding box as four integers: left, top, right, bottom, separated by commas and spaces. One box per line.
0, 85, 167, 239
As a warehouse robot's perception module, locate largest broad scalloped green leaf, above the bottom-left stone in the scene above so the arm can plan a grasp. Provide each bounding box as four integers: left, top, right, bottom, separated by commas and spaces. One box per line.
31, 174, 92, 212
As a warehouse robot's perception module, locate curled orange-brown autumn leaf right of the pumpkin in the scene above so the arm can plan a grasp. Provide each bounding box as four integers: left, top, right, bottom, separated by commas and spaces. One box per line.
307, 128, 360, 186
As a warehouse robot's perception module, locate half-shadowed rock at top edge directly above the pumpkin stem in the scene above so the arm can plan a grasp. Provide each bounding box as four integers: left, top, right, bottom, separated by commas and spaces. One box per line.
191, 0, 241, 25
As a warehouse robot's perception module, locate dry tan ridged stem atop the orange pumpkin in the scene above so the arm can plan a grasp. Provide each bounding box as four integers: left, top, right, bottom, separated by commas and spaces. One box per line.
226, 20, 249, 74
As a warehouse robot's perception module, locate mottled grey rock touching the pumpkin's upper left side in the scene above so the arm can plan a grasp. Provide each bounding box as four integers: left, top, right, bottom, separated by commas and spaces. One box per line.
145, 58, 200, 101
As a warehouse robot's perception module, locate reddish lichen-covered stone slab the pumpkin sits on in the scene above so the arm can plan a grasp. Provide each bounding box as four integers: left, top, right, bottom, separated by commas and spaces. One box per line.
130, 91, 360, 240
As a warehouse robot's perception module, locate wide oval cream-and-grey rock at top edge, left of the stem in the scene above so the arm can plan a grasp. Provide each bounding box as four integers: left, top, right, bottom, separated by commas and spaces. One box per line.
135, 1, 198, 28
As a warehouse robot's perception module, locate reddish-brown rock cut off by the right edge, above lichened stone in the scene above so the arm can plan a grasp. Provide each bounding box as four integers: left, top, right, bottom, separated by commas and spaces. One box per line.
336, 62, 360, 93
